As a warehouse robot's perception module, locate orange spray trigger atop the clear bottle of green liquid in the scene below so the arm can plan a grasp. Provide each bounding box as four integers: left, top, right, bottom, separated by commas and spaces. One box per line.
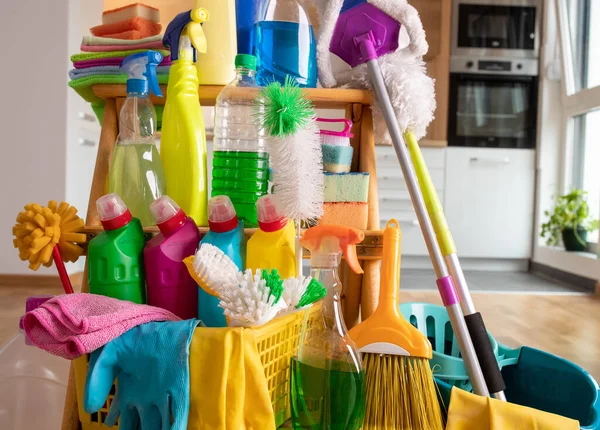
300, 225, 365, 274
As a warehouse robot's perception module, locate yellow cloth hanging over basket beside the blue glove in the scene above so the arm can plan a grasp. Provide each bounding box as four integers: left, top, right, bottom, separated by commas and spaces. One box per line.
188, 328, 275, 430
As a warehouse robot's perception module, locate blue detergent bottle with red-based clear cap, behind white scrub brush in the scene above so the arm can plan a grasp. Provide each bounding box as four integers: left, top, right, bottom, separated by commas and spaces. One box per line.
198, 196, 246, 327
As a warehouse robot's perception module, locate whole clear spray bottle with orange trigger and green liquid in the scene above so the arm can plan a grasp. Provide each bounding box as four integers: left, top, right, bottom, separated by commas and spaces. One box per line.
290, 226, 365, 430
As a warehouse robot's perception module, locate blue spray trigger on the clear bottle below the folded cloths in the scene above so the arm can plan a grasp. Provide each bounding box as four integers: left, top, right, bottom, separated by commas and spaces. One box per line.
121, 50, 163, 97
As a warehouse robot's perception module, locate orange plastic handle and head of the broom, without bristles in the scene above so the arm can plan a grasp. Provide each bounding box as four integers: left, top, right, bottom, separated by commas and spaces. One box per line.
350, 220, 433, 359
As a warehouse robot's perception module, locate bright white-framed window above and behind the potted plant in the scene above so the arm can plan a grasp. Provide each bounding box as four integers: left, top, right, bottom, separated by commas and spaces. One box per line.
555, 0, 600, 250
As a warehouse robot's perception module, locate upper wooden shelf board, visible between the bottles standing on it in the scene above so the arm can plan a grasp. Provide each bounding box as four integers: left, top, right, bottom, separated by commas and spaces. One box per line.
92, 84, 373, 108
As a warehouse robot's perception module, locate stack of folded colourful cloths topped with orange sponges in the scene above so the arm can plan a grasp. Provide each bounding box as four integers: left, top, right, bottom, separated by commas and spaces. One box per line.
69, 3, 171, 127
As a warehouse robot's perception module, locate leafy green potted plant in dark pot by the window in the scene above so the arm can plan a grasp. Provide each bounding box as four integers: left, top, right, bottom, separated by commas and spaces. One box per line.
540, 189, 598, 251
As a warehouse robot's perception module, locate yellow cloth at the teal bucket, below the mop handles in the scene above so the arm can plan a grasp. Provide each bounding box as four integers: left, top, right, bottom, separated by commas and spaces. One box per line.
446, 388, 580, 430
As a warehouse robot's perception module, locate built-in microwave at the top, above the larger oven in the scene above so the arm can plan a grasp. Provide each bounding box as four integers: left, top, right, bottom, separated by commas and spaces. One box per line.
452, 0, 542, 58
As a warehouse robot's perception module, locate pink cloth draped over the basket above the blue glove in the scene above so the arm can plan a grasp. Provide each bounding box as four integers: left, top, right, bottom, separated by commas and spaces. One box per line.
23, 293, 180, 360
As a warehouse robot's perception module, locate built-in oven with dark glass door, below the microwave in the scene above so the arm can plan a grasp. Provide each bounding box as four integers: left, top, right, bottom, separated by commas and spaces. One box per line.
448, 58, 538, 148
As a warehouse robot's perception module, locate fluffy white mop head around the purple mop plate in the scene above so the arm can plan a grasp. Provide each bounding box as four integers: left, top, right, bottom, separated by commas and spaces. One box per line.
315, 0, 436, 143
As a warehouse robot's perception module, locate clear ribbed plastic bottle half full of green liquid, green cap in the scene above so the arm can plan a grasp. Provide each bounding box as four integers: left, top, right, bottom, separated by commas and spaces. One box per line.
212, 55, 269, 228
